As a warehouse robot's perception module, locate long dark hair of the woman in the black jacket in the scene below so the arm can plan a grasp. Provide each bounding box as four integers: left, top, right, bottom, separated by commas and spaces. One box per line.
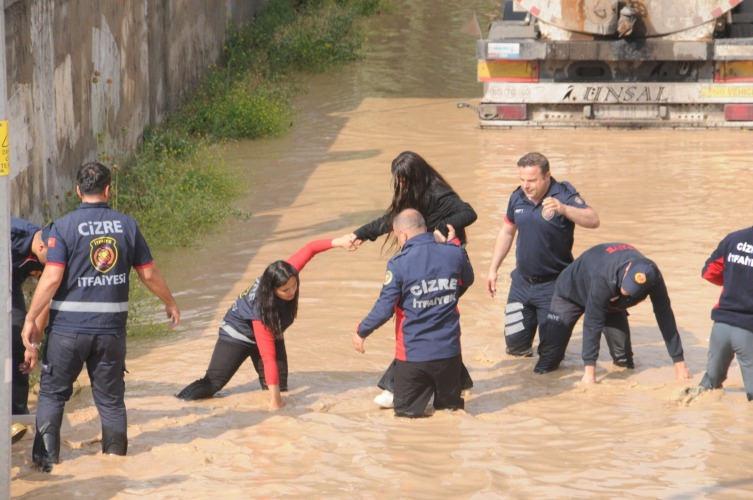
387, 151, 452, 220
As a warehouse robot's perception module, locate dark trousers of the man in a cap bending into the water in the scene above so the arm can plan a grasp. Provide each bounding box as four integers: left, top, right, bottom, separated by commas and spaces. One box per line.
534, 295, 633, 372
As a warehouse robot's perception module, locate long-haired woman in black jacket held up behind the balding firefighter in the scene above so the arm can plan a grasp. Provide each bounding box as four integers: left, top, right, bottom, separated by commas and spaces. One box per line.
350, 151, 477, 408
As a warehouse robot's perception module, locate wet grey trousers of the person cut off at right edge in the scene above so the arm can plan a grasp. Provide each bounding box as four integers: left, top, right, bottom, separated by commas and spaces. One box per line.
701, 322, 753, 401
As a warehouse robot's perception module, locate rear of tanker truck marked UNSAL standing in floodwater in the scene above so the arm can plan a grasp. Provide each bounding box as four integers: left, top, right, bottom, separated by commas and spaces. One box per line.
476, 0, 753, 128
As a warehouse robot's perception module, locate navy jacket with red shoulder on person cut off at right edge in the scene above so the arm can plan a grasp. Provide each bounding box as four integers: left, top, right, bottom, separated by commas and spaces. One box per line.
702, 227, 753, 332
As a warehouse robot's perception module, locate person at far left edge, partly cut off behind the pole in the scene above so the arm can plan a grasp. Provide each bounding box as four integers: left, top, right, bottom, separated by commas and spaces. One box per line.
10, 217, 50, 442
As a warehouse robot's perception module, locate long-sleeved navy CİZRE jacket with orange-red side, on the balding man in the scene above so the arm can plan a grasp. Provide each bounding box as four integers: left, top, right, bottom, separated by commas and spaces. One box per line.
358, 233, 473, 361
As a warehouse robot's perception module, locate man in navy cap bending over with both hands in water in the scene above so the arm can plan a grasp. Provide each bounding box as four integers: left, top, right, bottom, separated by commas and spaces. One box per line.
534, 243, 690, 383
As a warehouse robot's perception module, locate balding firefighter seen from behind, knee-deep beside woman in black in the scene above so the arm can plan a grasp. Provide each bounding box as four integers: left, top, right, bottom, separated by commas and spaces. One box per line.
353, 209, 473, 418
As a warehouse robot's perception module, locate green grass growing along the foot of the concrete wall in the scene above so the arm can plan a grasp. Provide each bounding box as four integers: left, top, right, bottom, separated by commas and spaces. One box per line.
112, 0, 383, 337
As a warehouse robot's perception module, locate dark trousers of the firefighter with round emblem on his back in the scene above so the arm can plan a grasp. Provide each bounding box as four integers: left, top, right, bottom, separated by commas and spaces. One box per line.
33, 330, 128, 463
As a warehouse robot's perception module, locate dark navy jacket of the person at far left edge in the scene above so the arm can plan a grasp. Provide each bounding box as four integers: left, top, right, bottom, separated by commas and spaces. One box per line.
10, 217, 44, 325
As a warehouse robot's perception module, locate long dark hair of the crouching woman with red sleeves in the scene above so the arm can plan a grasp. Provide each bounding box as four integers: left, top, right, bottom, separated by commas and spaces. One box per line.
256, 260, 301, 338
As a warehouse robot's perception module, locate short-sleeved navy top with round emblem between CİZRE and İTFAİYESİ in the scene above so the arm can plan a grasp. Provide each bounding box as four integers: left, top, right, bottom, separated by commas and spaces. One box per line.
47, 203, 152, 334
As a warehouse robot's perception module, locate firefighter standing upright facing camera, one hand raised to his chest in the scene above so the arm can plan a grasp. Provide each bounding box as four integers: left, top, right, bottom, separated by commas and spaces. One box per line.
486, 153, 630, 360
